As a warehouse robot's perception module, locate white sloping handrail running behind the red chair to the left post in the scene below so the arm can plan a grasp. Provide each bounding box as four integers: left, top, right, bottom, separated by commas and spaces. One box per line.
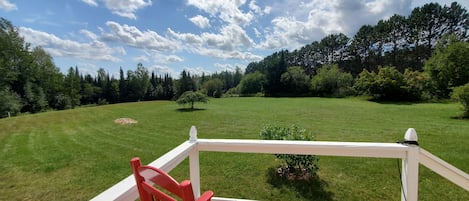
91, 141, 196, 201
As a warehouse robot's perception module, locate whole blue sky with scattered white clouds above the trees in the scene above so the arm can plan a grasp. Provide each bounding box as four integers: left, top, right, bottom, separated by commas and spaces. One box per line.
0, 0, 469, 78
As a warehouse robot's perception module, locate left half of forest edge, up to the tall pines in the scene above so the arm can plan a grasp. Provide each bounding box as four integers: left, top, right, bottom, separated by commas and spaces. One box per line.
0, 18, 243, 117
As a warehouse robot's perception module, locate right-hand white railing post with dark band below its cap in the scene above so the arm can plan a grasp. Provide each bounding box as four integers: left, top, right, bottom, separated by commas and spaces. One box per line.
401, 128, 419, 201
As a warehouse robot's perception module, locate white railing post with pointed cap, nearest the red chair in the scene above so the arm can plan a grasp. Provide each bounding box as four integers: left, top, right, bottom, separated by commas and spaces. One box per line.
189, 126, 200, 198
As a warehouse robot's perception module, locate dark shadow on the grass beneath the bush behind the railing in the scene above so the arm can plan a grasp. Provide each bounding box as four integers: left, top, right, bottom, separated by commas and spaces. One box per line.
267, 167, 334, 201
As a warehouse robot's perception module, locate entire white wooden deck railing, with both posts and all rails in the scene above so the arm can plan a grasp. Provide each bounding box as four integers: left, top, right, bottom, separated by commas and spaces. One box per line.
92, 126, 469, 201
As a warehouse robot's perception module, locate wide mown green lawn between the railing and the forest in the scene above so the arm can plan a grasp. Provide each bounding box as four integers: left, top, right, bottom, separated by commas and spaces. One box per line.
0, 98, 469, 200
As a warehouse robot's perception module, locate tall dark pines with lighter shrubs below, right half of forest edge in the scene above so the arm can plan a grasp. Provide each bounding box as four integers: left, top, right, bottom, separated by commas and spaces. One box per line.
238, 2, 469, 101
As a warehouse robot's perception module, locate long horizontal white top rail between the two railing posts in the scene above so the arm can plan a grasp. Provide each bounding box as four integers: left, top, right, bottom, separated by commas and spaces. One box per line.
197, 139, 409, 158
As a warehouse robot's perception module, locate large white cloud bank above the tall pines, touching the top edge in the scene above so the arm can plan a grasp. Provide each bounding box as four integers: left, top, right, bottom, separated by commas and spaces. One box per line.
257, 0, 411, 49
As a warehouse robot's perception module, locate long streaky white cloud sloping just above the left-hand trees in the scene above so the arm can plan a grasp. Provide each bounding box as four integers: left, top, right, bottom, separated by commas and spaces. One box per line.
19, 27, 121, 62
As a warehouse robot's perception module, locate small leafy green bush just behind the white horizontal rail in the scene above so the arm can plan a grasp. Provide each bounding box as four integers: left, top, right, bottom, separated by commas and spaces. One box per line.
260, 124, 319, 177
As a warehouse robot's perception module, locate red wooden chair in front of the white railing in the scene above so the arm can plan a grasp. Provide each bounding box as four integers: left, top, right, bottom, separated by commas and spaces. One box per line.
130, 157, 213, 201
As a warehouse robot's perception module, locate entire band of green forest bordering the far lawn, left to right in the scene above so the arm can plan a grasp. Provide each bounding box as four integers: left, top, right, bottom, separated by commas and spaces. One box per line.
0, 2, 469, 117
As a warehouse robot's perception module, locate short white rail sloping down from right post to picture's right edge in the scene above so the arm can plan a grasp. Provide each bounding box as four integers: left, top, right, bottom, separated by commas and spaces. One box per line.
419, 149, 469, 191
